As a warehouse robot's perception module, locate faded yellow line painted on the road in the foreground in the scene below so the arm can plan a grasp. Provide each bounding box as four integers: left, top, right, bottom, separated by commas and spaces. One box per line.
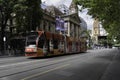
21, 64, 70, 80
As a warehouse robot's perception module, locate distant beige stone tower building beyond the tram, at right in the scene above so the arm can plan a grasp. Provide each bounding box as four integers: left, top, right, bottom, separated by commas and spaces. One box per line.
92, 19, 107, 47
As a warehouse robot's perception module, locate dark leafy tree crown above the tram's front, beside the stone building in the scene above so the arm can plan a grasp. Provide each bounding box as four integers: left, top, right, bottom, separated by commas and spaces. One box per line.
15, 0, 42, 32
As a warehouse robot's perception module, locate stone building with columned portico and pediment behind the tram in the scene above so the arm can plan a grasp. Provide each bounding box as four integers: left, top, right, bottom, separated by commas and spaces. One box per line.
39, 1, 81, 39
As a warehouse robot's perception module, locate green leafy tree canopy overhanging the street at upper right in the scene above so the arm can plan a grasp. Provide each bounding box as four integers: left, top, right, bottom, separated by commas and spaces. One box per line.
74, 0, 120, 42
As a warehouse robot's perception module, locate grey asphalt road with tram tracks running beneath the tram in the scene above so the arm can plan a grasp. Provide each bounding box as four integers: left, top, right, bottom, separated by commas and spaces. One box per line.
0, 49, 120, 80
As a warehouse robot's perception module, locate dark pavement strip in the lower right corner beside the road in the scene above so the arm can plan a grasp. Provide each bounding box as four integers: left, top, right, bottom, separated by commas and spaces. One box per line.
100, 50, 120, 80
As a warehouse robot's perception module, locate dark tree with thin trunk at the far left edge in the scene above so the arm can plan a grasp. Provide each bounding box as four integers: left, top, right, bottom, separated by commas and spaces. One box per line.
0, 0, 16, 53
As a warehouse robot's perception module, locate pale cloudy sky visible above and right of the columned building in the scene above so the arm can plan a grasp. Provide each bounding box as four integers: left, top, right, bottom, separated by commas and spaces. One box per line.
42, 0, 93, 30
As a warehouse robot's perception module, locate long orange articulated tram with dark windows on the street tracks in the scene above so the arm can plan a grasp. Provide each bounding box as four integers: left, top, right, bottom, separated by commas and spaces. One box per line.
25, 31, 87, 57
